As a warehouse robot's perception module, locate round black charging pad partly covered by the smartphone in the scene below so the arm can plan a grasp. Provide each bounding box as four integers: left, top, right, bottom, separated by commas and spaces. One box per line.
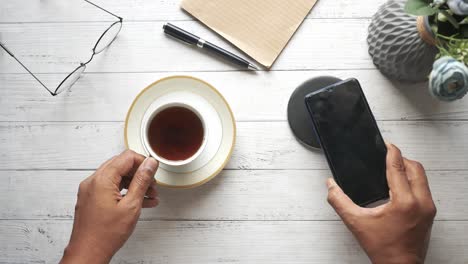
288, 76, 342, 149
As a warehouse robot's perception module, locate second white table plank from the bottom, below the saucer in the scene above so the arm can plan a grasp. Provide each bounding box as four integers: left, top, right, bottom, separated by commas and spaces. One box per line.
0, 170, 468, 221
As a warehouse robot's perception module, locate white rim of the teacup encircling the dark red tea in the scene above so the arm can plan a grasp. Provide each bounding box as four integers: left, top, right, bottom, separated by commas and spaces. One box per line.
141, 99, 209, 167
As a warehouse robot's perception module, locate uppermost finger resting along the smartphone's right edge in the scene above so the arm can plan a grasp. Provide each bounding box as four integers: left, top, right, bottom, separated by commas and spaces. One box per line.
386, 144, 411, 199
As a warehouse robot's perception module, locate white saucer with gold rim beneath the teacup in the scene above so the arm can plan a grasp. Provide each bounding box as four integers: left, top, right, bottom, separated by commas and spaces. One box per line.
125, 76, 236, 188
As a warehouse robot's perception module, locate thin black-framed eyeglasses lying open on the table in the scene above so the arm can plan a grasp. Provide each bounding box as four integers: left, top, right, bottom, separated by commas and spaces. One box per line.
0, 0, 123, 96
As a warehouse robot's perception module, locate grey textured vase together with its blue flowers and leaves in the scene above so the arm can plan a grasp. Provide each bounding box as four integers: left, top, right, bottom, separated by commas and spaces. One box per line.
367, 0, 468, 101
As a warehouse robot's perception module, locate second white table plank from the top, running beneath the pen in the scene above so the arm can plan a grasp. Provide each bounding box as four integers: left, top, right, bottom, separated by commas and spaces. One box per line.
0, 19, 374, 73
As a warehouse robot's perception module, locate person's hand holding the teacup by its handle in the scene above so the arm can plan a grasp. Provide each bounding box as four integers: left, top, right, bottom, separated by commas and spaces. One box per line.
61, 150, 159, 263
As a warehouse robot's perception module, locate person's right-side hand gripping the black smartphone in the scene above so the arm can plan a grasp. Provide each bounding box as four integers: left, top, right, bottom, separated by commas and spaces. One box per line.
327, 144, 436, 263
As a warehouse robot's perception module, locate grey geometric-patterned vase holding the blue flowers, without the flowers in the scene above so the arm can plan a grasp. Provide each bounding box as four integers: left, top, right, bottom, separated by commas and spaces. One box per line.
367, 0, 438, 82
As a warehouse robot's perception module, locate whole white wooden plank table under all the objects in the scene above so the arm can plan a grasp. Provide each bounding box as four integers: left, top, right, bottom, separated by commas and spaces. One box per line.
0, 0, 468, 263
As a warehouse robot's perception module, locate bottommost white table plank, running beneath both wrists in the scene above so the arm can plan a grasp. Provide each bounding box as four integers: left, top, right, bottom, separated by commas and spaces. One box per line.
0, 221, 468, 264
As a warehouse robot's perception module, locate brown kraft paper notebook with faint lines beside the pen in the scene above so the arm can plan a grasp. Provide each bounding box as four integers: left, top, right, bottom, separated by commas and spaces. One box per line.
181, 0, 317, 68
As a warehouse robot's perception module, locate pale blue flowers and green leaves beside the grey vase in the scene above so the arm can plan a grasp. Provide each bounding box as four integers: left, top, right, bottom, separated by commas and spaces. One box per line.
405, 0, 468, 101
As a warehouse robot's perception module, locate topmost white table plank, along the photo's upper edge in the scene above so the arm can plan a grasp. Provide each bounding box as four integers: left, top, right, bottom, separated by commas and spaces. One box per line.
0, 0, 385, 23
